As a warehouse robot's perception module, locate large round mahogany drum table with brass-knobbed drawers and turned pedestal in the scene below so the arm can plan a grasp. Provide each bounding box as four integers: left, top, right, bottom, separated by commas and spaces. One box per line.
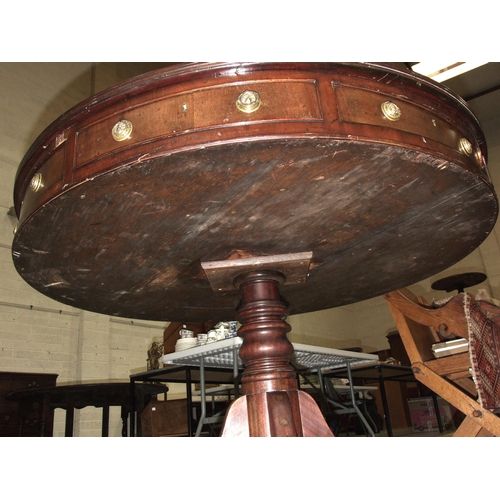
12, 63, 498, 435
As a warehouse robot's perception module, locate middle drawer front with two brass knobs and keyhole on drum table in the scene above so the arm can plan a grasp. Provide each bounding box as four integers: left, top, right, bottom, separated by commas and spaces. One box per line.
75, 81, 321, 168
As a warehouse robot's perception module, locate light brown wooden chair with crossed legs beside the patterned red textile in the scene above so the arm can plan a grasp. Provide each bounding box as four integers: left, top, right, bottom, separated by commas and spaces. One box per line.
384, 289, 500, 436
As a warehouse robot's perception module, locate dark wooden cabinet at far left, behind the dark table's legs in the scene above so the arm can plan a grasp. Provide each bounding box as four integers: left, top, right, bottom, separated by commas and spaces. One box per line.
0, 372, 57, 437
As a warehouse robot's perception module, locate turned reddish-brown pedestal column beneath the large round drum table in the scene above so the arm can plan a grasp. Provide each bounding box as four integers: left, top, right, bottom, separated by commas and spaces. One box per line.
222, 270, 333, 437
